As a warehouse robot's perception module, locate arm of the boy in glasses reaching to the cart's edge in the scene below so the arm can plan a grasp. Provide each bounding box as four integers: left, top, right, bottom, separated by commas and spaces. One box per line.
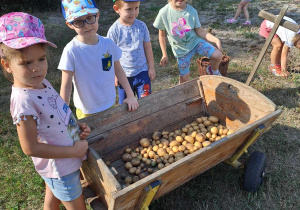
114, 61, 139, 111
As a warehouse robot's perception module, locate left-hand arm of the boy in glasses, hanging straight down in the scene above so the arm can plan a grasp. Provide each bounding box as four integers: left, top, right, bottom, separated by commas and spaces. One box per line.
60, 70, 74, 105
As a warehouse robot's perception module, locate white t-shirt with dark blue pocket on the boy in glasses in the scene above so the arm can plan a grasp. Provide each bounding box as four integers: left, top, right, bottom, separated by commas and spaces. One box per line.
58, 35, 122, 114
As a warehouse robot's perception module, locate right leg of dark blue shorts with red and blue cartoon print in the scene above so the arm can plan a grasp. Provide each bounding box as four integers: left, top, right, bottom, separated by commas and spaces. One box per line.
133, 71, 151, 98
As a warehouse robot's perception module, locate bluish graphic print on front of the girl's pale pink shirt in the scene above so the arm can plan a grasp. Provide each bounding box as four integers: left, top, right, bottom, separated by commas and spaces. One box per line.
48, 95, 80, 142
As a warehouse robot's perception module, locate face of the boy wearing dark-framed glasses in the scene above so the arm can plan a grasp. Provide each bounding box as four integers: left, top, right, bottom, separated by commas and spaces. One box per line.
67, 13, 99, 39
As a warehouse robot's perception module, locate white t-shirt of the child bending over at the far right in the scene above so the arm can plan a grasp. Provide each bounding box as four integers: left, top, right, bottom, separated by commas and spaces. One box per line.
266, 16, 297, 47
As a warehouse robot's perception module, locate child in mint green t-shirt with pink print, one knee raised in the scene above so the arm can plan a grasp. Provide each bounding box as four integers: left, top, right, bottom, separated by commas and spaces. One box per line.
153, 0, 222, 83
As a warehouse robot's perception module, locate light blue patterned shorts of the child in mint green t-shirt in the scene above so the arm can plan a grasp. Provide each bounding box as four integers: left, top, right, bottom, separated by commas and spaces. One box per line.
177, 40, 216, 76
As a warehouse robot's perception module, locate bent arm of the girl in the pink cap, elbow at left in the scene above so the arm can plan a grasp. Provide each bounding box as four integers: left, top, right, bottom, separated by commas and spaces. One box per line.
17, 116, 88, 159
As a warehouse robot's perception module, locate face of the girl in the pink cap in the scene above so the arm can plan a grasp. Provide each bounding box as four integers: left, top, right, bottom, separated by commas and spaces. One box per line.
3, 44, 48, 89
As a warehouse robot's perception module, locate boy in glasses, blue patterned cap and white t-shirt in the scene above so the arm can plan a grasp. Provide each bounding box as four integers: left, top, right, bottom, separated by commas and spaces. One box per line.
58, 0, 138, 119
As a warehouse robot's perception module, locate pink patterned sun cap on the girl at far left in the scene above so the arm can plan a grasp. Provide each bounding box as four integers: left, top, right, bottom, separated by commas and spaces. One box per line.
0, 12, 57, 49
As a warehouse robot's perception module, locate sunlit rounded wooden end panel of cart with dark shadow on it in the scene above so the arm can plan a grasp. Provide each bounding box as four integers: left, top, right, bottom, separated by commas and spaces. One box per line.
200, 76, 276, 130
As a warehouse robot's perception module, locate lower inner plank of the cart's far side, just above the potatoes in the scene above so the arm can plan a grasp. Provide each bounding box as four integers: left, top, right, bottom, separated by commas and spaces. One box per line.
90, 97, 202, 157
